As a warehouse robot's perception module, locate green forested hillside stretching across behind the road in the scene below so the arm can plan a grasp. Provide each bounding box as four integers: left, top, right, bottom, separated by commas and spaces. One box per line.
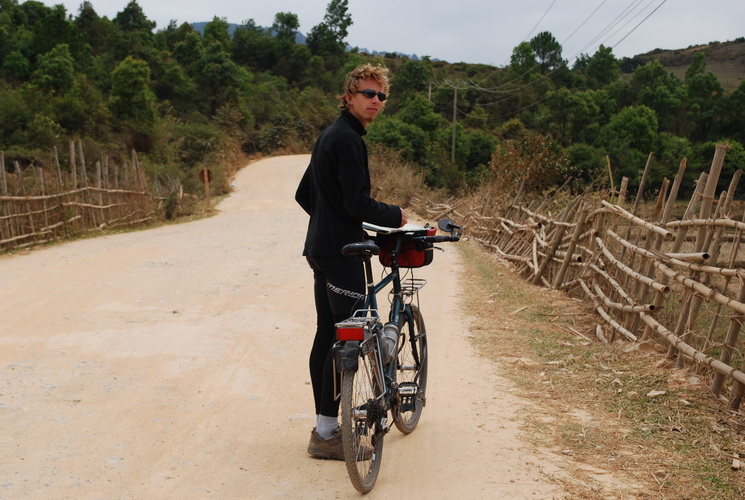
0, 0, 745, 211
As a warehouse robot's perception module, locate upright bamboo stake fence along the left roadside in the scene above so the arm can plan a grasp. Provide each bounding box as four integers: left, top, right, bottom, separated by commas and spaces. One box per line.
0, 141, 156, 252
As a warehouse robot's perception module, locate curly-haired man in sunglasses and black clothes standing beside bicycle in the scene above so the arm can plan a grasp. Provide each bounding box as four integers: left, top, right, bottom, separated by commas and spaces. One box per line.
295, 64, 407, 460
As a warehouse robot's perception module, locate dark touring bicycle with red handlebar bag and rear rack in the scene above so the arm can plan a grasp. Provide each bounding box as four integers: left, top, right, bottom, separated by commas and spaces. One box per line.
333, 219, 463, 493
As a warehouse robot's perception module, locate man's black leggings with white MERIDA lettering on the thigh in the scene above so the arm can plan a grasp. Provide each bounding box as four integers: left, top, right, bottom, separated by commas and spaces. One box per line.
307, 256, 365, 417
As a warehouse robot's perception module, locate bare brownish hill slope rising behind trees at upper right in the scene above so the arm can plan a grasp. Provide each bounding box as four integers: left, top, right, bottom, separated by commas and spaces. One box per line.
623, 37, 745, 90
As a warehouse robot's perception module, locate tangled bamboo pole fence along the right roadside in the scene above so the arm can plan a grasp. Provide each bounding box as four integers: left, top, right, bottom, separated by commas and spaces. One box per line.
419, 144, 745, 409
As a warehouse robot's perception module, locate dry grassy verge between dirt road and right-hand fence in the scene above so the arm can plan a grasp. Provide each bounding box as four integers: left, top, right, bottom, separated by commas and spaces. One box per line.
458, 242, 745, 499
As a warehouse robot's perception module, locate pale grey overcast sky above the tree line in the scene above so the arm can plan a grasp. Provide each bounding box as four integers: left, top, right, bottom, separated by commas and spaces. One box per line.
39, 0, 745, 66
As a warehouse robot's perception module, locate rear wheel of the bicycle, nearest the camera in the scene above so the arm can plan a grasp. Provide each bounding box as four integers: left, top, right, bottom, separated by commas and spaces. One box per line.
341, 351, 385, 493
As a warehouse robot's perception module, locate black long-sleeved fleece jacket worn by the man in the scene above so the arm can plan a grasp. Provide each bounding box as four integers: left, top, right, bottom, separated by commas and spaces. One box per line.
295, 110, 401, 257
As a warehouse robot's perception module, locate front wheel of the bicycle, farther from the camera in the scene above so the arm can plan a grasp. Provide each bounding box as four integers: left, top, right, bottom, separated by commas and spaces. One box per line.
394, 305, 428, 434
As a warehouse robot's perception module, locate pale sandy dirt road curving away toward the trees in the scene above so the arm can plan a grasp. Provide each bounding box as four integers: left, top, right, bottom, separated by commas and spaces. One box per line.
0, 156, 562, 499
